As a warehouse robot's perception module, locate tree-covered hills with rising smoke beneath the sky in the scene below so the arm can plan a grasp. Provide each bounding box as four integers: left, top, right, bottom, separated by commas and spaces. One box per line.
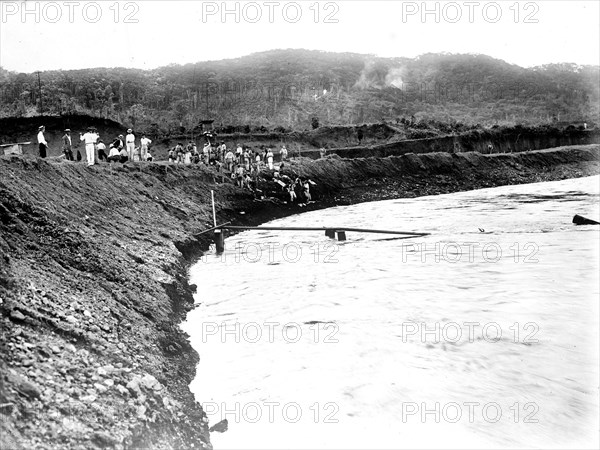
0, 50, 600, 137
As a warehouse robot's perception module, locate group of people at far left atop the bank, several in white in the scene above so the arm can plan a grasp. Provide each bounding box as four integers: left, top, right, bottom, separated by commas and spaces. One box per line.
37, 125, 153, 166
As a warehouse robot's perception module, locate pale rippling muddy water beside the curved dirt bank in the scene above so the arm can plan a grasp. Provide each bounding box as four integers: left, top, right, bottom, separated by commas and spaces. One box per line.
184, 177, 600, 449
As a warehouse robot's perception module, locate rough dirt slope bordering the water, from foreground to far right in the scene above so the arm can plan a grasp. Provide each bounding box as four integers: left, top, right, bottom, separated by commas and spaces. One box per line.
0, 145, 600, 449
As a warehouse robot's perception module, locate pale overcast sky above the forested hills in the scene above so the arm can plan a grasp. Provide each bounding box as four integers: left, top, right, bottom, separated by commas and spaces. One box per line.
0, 0, 600, 72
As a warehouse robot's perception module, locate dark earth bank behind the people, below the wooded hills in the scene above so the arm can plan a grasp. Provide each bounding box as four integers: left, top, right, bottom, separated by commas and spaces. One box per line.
0, 115, 600, 160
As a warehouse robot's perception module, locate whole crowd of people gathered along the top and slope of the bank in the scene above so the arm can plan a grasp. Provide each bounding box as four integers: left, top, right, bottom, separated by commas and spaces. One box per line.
38, 126, 314, 203
